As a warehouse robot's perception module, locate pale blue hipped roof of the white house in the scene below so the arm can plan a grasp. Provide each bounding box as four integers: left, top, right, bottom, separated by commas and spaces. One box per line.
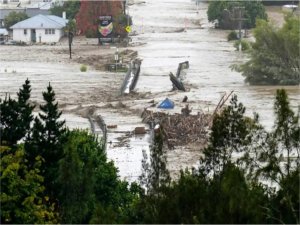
10, 14, 68, 29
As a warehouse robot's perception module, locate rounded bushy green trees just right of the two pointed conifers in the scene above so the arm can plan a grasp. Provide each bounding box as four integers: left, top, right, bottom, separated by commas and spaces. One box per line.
58, 130, 139, 223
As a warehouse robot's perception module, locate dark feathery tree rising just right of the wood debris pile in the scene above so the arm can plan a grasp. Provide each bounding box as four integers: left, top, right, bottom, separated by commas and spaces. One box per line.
200, 95, 250, 174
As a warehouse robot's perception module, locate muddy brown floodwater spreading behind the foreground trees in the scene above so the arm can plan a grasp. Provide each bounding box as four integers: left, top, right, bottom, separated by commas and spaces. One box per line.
0, 0, 300, 181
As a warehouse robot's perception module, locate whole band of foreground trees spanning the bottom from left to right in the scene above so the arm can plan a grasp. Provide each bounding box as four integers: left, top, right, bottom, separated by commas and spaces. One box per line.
0, 80, 300, 224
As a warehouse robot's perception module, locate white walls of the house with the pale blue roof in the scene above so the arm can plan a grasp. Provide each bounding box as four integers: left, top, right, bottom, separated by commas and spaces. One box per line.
13, 29, 64, 43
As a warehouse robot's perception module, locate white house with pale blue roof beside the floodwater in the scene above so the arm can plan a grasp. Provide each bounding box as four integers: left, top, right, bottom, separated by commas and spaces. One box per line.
10, 15, 68, 43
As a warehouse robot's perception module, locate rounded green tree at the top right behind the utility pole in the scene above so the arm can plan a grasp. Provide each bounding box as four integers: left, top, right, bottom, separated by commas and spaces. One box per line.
207, 0, 267, 29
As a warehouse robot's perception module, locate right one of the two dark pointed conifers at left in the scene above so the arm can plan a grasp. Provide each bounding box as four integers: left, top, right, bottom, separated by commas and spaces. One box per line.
25, 83, 66, 198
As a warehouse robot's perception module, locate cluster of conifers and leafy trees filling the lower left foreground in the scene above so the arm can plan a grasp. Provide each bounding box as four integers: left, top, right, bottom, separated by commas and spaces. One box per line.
0, 80, 140, 223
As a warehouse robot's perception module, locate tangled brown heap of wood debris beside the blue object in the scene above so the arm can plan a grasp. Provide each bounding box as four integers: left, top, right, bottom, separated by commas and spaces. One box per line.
142, 107, 211, 148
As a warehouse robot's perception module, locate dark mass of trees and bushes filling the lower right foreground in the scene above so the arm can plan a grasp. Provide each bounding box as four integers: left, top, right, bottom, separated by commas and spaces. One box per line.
131, 90, 300, 224
